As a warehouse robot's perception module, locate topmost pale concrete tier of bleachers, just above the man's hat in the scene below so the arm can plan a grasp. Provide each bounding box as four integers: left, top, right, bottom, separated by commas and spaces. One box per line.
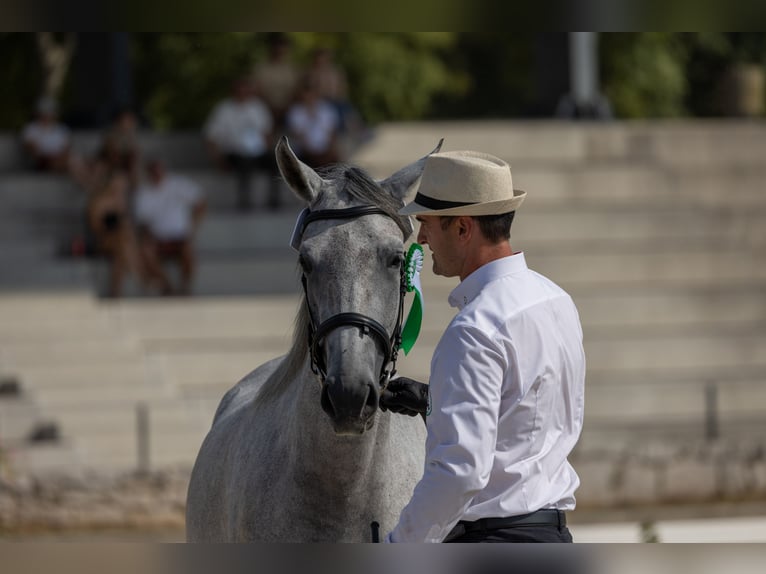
352, 120, 766, 169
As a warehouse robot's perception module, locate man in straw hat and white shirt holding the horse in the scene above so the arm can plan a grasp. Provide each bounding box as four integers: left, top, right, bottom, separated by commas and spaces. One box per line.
381, 151, 585, 542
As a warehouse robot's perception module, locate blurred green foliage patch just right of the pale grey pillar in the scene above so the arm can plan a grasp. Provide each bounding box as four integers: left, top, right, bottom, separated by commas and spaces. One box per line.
600, 32, 688, 118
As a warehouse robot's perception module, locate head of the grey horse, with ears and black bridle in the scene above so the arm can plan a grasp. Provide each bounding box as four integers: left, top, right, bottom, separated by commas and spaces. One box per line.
276, 137, 441, 434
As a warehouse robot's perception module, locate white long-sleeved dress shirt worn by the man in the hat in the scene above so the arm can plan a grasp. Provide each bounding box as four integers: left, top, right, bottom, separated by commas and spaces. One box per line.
387, 253, 585, 542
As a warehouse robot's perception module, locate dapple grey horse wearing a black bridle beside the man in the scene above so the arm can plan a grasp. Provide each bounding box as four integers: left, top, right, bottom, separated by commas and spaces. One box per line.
186, 137, 441, 542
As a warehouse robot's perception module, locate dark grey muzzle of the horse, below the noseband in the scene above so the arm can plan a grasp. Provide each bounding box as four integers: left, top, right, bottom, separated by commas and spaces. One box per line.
321, 376, 380, 434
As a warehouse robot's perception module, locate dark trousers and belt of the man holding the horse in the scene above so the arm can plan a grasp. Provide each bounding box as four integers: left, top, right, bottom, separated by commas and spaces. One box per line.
444, 510, 572, 543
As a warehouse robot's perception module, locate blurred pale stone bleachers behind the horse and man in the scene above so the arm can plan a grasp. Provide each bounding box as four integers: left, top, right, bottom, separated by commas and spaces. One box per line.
0, 122, 766, 490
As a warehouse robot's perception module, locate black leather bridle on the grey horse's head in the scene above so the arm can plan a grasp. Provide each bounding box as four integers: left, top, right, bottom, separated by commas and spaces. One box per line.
296, 205, 407, 387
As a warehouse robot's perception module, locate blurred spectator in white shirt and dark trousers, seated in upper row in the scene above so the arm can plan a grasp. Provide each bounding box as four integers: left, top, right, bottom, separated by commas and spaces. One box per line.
203, 79, 280, 210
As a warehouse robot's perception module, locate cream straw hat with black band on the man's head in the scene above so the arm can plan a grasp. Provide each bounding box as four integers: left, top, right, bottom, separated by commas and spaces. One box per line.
399, 151, 526, 215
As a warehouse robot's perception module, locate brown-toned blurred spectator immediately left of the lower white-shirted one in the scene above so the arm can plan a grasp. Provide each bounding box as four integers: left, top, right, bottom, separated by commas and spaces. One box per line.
87, 171, 141, 297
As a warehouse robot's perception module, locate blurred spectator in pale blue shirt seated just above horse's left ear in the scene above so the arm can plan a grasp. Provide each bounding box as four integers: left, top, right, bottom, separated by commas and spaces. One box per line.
287, 78, 340, 168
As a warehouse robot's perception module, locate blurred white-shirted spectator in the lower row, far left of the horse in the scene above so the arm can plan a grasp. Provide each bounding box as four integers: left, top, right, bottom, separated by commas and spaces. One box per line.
135, 160, 206, 295
